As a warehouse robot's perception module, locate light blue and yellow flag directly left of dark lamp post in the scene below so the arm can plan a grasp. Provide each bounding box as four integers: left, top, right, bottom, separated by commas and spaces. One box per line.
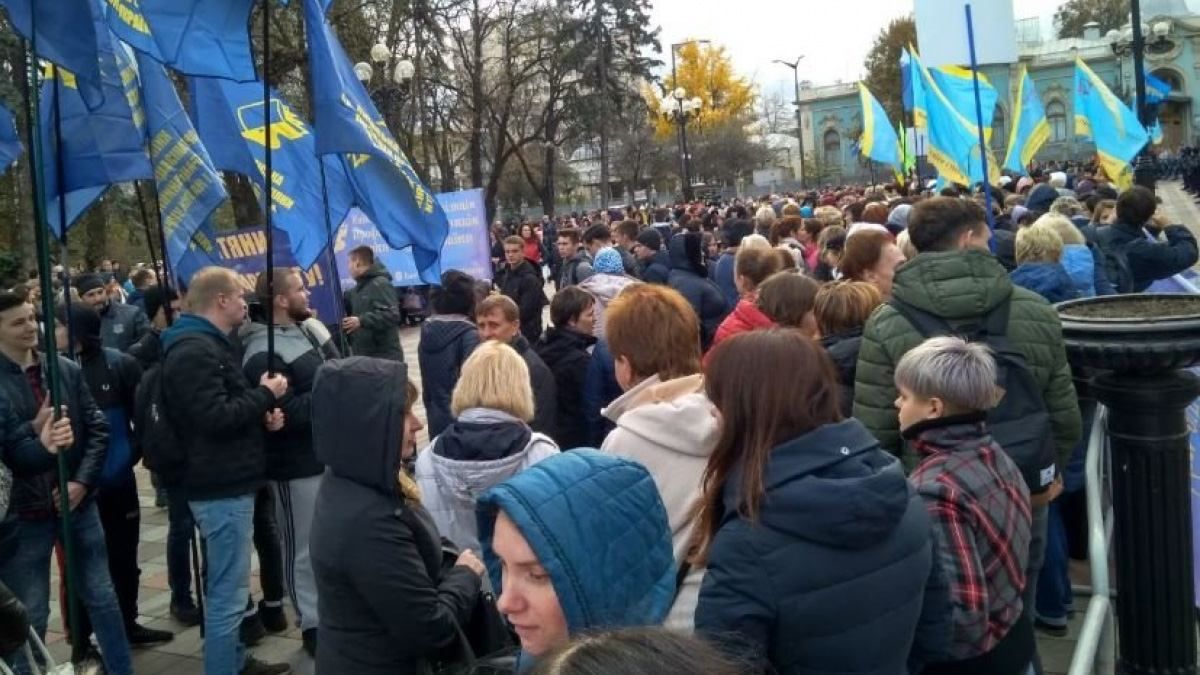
1075, 59, 1150, 190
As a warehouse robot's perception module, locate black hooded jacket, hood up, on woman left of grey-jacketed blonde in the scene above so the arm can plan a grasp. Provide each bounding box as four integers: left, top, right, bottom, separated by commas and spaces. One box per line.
311, 357, 480, 675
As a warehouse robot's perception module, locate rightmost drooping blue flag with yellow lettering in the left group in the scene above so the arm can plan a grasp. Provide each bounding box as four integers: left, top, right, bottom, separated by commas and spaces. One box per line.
305, 0, 450, 283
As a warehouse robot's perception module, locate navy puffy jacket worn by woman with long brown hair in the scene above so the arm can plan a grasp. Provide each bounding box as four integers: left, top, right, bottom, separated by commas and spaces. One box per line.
696, 419, 947, 675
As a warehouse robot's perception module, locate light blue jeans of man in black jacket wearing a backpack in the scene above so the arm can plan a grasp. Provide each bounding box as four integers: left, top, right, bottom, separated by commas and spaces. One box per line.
188, 495, 254, 675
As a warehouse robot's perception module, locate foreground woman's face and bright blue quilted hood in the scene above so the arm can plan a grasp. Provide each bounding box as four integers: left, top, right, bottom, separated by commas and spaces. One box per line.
478, 449, 678, 670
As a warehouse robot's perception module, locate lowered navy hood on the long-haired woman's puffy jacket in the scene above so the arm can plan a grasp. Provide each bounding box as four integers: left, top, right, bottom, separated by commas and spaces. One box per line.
724, 419, 911, 549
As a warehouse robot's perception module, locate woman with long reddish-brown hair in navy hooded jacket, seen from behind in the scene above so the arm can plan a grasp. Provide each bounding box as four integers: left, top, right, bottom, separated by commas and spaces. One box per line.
692, 329, 950, 675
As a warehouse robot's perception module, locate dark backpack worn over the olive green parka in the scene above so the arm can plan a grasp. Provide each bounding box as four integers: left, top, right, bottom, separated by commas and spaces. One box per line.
888, 297, 1056, 495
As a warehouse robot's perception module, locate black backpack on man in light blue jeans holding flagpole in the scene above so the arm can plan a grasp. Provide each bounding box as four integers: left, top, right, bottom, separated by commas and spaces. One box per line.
133, 336, 196, 486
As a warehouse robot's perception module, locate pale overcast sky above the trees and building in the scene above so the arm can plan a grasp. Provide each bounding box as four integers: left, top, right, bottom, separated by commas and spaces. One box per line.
652, 0, 1194, 96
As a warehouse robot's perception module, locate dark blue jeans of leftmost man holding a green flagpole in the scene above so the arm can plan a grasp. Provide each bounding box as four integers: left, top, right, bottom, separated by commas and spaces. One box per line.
0, 498, 133, 675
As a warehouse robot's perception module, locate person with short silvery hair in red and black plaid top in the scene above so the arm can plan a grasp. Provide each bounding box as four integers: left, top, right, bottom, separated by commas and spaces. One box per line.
895, 336, 1034, 675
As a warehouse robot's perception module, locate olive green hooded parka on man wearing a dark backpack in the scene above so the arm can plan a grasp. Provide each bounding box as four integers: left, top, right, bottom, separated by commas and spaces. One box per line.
854, 250, 1082, 471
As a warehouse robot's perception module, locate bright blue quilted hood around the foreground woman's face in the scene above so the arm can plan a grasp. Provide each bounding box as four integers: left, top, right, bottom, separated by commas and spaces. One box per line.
478, 449, 676, 635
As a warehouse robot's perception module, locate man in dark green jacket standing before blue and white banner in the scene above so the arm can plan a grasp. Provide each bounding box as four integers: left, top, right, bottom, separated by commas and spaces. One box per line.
342, 246, 404, 362
